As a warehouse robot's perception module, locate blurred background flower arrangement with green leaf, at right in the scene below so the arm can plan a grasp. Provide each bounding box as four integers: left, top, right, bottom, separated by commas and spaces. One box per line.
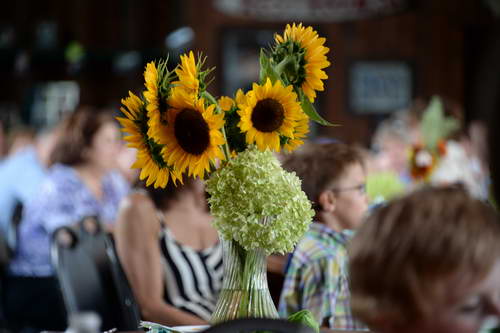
409, 96, 460, 182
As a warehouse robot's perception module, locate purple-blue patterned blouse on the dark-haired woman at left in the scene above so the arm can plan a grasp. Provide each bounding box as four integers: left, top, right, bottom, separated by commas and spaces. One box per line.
9, 164, 129, 276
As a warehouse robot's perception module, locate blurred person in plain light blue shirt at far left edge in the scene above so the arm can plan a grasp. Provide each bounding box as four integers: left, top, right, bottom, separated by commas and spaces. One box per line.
0, 125, 60, 232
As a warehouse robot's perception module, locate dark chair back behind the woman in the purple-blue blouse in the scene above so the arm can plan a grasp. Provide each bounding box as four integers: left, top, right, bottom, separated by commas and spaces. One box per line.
52, 217, 140, 331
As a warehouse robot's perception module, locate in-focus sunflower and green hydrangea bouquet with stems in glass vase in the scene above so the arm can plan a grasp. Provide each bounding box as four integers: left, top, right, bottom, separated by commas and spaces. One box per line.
118, 24, 331, 321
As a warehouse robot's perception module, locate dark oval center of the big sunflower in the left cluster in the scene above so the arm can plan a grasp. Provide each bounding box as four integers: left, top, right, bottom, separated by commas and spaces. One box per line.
174, 109, 210, 155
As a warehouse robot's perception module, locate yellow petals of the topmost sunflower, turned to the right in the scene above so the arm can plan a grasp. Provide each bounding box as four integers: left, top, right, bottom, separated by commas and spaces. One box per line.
275, 23, 330, 103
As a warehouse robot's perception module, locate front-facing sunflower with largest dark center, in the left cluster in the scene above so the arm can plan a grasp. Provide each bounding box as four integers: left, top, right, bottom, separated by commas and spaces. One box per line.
162, 87, 225, 179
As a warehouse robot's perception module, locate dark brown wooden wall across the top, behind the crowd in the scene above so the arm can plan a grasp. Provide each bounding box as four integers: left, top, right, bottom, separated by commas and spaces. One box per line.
0, 0, 488, 143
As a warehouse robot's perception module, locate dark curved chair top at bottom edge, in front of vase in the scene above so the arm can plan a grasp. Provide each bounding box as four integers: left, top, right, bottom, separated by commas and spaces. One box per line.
204, 318, 314, 333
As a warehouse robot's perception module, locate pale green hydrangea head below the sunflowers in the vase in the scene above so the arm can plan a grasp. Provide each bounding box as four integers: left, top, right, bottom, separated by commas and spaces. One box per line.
207, 147, 314, 254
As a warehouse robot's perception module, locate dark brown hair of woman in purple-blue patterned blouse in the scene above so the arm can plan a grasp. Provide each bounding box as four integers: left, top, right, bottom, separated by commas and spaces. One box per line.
50, 106, 115, 166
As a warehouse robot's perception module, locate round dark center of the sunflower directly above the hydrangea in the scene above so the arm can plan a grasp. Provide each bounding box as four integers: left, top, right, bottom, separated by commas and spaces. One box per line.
252, 98, 285, 132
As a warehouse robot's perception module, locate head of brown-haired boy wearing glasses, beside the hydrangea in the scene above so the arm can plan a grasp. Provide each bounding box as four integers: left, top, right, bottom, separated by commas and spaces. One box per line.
283, 143, 368, 229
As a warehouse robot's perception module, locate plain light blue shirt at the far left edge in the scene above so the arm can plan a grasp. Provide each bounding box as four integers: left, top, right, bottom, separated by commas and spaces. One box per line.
0, 146, 47, 232
